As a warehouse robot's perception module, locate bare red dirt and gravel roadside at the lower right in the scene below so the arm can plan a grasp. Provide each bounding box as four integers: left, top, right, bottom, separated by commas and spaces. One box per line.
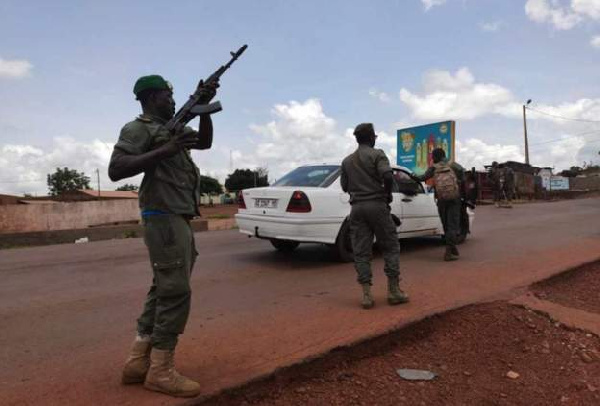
202, 263, 600, 406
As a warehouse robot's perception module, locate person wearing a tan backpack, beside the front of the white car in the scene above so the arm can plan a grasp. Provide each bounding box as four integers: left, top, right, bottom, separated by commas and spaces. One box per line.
415, 148, 465, 261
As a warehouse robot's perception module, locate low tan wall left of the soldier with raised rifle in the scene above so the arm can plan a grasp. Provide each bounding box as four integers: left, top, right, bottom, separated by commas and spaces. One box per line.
0, 199, 140, 233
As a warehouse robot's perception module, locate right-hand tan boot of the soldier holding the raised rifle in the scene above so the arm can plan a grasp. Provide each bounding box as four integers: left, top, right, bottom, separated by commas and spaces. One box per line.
144, 348, 200, 398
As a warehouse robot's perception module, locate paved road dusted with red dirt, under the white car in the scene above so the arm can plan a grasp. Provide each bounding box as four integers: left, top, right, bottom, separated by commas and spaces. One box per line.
0, 198, 600, 405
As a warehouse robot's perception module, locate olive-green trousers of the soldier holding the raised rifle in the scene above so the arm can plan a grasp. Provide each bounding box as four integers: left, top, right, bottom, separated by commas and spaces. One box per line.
137, 214, 198, 350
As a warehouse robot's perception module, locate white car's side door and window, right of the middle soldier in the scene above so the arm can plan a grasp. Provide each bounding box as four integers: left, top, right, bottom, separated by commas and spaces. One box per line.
394, 169, 439, 233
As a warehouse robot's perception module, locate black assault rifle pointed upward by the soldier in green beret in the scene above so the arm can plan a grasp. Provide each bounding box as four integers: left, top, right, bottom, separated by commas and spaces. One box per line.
165, 45, 248, 134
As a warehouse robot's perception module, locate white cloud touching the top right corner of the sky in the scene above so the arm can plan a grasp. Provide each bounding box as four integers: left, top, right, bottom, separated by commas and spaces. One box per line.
525, 0, 600, 30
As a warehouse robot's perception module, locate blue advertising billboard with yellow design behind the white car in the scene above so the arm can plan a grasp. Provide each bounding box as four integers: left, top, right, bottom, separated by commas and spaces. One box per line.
396, 121, 455, 175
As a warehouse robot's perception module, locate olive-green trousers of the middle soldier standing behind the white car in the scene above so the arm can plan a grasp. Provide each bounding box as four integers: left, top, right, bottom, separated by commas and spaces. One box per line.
350, 200, 400, 285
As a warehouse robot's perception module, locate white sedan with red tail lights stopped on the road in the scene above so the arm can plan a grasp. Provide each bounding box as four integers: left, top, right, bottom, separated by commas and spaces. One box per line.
235, 164, 473, 261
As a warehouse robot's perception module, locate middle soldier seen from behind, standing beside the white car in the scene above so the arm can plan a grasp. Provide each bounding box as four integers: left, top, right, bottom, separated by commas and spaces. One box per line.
340, 123, 408, 309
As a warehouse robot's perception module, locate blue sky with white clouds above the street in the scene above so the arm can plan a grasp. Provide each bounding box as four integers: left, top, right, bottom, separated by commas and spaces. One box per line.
0, 0, 600, 194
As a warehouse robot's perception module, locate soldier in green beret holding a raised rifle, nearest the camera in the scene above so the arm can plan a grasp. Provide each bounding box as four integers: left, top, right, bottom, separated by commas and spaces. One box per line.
108, 75, 218, 397
